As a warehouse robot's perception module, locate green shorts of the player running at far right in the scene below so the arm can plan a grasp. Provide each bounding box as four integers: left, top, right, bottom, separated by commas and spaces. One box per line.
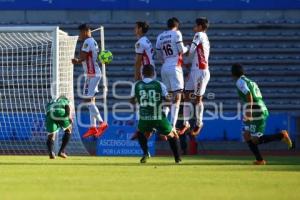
243, 111, 269, 137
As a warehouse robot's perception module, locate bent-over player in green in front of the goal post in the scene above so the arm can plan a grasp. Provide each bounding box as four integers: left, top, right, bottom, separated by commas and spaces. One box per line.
46, 96, 72, 159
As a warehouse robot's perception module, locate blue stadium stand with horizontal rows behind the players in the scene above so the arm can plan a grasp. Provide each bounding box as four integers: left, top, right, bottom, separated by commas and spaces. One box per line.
63, 21, 300, 113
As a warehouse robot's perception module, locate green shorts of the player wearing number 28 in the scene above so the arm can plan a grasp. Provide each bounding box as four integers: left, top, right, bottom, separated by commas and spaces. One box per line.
138, 117, 172, 135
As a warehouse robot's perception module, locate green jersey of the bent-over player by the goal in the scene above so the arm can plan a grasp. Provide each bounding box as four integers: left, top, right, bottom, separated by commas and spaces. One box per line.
46, 97, 70, 118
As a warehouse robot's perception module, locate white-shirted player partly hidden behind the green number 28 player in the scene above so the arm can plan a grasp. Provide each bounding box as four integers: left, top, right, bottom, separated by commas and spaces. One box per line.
134, 21, 155, 81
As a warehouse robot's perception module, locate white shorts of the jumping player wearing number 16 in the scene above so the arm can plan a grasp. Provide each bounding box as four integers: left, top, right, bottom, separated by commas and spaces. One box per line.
161, 66, 184, 92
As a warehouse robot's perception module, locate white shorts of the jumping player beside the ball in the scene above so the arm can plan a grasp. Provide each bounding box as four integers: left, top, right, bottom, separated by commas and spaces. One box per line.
83, 76, 101, 98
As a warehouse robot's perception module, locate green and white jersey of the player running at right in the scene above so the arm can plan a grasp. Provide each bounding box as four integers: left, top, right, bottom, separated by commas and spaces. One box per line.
236, 76, 268, 113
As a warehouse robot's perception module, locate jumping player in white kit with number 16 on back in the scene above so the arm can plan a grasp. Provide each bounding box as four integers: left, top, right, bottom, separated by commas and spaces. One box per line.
156, 17, 188, 130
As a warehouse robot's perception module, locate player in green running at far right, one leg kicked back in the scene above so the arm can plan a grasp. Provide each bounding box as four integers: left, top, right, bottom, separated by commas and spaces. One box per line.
231, 63, 292, 165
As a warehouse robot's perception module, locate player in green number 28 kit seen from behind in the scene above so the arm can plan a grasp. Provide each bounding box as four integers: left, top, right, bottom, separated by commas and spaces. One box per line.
131, 65, 181, 163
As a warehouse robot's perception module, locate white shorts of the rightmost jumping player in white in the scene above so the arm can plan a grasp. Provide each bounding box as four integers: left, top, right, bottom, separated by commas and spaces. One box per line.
184, 69, 210, 96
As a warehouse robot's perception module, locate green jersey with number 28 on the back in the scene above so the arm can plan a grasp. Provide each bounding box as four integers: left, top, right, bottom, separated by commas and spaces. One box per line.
132, 78, 167, 120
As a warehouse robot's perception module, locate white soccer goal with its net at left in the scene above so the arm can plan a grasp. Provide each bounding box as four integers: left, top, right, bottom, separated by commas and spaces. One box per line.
0, 27, 87, 155
